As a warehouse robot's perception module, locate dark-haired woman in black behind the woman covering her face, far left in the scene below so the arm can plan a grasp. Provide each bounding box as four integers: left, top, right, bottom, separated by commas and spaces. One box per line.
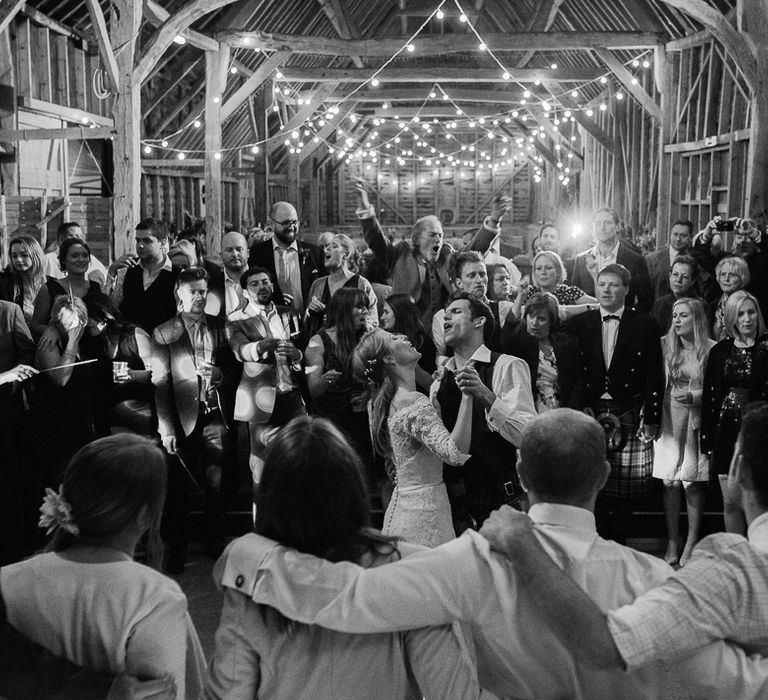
30, 238, 101, 338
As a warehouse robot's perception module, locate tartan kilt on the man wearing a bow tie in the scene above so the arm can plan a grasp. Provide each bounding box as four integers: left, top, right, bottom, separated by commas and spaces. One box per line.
599, 399, 653, 499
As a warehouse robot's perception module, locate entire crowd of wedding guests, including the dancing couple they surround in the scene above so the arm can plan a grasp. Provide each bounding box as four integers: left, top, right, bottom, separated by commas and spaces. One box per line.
0, 183, 768, 697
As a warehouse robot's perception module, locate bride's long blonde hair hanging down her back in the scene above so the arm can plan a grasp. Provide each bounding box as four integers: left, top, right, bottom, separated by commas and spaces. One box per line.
352, 328, 397, 458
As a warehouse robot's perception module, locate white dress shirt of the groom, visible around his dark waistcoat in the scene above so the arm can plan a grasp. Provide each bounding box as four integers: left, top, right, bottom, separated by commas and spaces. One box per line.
429, 345, 536, 447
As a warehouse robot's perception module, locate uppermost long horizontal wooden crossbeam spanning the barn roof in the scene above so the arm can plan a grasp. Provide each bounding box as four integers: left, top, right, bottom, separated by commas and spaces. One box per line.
219, 30, 663, 58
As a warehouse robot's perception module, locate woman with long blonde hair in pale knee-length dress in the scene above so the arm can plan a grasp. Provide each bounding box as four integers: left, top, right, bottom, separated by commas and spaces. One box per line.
653, 298, 715, 566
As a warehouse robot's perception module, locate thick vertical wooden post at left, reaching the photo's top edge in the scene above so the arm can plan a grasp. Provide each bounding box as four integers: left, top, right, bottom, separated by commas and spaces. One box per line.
110, 0, 141, 257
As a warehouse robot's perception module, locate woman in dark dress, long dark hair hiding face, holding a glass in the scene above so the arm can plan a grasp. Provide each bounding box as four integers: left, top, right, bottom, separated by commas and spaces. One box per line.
81, 292, 155, 436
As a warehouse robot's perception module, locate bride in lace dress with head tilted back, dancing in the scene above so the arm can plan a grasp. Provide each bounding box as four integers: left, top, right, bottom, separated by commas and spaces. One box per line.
352, 329, 472, 547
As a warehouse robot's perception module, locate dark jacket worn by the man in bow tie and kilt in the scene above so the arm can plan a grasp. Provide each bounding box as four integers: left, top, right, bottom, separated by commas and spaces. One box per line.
566, 307, 666, 425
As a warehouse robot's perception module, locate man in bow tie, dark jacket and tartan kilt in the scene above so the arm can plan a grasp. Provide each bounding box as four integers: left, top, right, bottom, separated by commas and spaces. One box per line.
568, 263, 664, 544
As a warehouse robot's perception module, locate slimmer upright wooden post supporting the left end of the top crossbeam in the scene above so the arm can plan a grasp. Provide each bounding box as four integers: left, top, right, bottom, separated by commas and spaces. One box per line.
205, 45, 229, 254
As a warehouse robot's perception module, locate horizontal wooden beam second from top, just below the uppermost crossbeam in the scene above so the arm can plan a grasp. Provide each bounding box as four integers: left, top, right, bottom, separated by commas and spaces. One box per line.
282, 66, 604, 84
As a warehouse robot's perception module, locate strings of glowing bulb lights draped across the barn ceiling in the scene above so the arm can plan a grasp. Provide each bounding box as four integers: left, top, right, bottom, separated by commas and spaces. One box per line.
142, 0, 651, 185
